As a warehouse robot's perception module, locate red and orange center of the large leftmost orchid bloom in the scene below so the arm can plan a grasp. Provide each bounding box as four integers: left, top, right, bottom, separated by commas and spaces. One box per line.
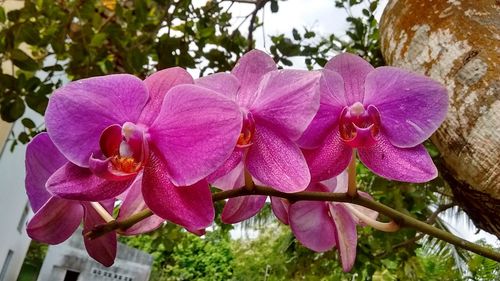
100, 122, 148, 174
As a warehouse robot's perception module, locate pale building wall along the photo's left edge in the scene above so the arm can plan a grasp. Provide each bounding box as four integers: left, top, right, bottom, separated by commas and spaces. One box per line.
0, 0, 32, 281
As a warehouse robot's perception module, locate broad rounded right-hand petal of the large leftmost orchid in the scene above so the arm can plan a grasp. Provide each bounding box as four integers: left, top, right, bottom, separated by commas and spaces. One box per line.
149, 85, 243, 186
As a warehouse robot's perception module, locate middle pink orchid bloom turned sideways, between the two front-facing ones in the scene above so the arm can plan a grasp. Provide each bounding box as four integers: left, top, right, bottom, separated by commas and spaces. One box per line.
195, 50, 320, 223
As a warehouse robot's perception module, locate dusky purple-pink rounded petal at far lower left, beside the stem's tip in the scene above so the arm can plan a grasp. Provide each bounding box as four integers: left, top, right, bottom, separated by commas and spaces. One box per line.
26, 197, 83, 245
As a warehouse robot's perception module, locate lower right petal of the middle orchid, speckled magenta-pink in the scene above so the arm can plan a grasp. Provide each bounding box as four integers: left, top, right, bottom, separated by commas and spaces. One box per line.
246, 126, 311, 192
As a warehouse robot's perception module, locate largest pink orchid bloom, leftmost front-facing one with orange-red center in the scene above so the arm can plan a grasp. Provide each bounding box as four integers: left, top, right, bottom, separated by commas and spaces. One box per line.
45, 68, 242, 229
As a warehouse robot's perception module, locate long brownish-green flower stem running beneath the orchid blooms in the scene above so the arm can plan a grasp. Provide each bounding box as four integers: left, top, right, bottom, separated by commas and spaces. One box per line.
85, 185, 500, 262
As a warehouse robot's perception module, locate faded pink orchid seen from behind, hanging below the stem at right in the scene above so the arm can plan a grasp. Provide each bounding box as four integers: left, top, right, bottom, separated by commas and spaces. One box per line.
271, 172, 378, 272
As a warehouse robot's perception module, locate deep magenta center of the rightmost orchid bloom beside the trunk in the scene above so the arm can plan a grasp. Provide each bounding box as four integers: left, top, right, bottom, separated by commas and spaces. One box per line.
339, 102, 380, 147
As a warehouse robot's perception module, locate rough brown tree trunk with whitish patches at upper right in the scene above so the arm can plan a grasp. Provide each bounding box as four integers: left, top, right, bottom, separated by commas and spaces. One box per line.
380, 0, 500, 237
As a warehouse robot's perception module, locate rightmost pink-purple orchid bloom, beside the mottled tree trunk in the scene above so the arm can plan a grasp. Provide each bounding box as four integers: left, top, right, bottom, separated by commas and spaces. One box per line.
298, 53, 448, 182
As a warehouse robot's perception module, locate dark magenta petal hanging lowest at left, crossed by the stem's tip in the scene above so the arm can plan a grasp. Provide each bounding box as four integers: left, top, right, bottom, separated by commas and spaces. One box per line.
83, 200, 117, 267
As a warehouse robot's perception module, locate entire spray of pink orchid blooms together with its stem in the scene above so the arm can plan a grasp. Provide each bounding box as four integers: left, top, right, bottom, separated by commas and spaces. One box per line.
26, 50, 500, 271
